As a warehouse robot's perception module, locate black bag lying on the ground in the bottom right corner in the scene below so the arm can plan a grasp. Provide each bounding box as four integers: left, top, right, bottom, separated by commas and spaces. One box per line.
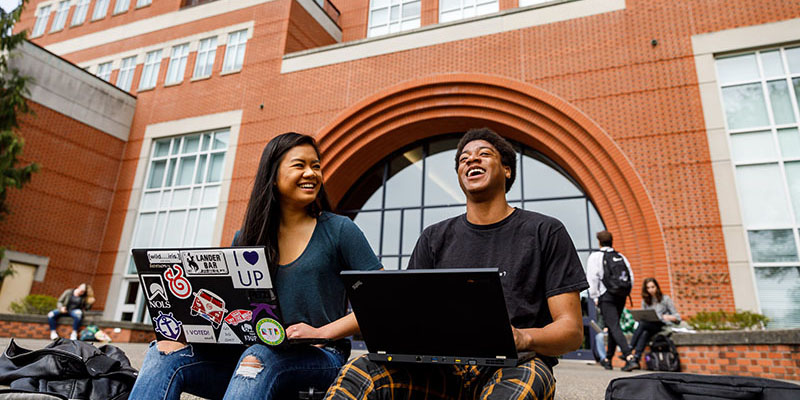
606, 372, 800, 400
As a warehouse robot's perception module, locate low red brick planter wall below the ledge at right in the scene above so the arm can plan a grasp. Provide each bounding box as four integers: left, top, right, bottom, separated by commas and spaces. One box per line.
678, 345, 800, 380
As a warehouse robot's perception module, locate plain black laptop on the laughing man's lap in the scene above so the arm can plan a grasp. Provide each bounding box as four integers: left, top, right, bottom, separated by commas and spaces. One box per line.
341, 268, 520, 367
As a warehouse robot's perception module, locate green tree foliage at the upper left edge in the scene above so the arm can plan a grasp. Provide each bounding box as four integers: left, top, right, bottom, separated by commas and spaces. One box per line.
0, 0, 39, 220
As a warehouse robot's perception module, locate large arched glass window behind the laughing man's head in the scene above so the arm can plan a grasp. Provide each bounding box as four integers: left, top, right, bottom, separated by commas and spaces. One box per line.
339, 135, 604, 269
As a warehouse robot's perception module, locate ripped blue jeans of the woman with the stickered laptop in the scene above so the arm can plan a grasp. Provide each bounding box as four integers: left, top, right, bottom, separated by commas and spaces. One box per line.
130, 342, 347, 400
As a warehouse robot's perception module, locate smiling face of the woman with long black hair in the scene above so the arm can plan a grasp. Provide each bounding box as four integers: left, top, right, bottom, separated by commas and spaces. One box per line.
276, 144, 322, 211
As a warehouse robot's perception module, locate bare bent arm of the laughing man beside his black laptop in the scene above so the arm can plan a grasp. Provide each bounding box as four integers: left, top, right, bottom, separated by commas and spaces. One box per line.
513, 292, 583, 356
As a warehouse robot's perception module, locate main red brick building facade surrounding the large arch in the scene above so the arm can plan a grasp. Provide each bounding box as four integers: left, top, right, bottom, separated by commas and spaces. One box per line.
15, 0, 798, 315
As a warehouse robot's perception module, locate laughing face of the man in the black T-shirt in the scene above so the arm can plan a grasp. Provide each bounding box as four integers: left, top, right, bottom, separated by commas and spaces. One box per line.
457, 140, 511, 200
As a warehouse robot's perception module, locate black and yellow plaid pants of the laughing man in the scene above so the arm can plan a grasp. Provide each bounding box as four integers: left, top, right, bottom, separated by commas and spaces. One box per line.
325, 356, 556, 400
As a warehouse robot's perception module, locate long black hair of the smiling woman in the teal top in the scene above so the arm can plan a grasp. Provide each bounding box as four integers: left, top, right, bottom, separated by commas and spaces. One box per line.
236, 132, 331, 275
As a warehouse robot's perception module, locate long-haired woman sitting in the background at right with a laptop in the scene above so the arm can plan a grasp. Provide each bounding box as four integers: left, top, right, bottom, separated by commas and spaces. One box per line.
622, 278, 681, 371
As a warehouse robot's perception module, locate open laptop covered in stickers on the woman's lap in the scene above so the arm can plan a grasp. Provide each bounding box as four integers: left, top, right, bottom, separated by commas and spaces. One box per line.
131, 247, 326, 346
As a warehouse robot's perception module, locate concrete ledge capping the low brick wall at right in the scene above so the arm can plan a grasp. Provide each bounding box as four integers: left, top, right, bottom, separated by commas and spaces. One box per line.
672, 329, 800, 347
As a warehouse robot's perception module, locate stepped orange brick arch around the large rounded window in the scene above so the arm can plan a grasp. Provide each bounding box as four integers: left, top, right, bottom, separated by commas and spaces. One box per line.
317, 74, 671, 295
